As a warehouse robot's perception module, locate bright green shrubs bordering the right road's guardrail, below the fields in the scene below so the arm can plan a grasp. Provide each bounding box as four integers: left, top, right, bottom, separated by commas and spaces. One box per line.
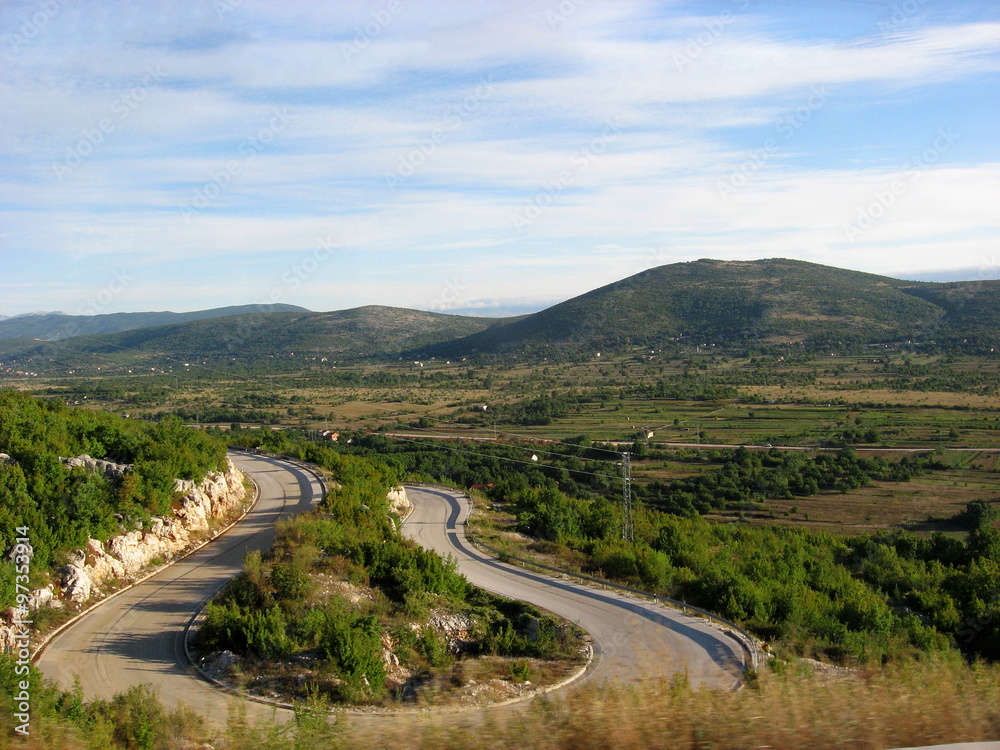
487, 475, 1000, 662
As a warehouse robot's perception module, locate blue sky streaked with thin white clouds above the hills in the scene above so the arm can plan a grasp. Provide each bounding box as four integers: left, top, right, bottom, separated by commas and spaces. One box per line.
0, 0, 1000, 316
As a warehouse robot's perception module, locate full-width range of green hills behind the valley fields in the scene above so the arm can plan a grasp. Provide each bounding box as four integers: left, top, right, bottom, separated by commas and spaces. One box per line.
0, 258, 1000, 368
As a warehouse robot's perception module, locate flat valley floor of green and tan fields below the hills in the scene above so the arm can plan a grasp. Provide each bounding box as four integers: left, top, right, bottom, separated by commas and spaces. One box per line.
5, 349, 1000, 548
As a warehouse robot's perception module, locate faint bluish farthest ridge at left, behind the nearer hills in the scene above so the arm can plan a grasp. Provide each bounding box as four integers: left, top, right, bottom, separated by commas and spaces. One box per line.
0, 305, 308, 341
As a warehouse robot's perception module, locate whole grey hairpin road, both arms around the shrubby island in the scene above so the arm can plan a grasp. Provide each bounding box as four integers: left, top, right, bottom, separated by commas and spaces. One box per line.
36, 453, 744, 724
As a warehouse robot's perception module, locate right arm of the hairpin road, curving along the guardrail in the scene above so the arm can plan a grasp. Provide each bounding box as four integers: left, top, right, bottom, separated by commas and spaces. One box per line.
403, 486, 746, 688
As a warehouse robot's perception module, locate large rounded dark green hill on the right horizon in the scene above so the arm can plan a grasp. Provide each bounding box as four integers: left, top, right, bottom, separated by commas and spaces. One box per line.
426, 259, 1000, 356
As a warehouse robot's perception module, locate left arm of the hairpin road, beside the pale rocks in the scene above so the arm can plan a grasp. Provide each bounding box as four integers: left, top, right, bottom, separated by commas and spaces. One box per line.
36, 451, 322, 723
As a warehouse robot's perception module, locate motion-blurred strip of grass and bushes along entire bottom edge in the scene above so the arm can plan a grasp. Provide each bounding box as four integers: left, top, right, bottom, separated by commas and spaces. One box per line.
0, 659, 1000, 750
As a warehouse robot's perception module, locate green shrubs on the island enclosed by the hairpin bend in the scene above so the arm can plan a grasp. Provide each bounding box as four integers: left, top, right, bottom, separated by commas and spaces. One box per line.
190, 443, 574, 702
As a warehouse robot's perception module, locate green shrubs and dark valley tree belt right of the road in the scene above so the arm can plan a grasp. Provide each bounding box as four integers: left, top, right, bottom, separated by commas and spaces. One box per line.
225, 433, 1000, 662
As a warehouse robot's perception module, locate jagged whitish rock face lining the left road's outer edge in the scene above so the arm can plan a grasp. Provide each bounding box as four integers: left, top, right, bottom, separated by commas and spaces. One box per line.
61, 457, 246, 604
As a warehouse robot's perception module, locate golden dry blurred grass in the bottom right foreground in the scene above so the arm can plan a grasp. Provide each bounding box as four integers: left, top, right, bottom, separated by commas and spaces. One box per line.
347, 663, 1000, 750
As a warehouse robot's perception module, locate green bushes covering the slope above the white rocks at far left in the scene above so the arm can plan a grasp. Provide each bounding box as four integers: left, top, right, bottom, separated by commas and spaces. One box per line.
0, 390, 226, 605
